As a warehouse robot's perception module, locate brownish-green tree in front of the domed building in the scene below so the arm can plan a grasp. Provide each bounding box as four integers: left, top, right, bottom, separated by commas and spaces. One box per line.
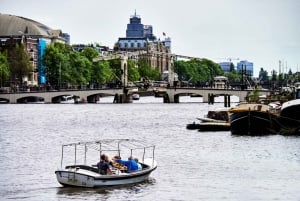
9, 43, 33, 84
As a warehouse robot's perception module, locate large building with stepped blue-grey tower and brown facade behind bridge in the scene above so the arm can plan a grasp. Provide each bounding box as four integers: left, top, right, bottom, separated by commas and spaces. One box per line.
114, 13, 171, 73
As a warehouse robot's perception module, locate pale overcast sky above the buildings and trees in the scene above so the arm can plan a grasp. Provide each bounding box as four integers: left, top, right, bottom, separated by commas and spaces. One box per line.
0, 0, 300, 77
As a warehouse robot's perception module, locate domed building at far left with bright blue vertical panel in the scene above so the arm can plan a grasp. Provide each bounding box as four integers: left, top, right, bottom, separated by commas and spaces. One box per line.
0, 14, 70, 86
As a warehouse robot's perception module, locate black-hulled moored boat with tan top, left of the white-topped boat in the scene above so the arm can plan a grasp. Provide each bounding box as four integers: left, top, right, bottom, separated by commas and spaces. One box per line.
229, 103, 280, 135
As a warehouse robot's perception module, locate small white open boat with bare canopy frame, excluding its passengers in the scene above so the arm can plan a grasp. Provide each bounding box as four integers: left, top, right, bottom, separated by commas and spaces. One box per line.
55, 139, 157, 188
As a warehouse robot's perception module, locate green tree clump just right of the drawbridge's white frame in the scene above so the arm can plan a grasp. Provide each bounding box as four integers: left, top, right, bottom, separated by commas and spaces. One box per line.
174, 59, 223, 83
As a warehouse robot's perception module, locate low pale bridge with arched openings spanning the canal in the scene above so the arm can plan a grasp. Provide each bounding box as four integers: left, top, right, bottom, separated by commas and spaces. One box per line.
0, 87, 270, 103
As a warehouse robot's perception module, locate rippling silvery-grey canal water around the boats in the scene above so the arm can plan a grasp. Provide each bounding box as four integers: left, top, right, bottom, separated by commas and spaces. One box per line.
0, 97, 300, 201
